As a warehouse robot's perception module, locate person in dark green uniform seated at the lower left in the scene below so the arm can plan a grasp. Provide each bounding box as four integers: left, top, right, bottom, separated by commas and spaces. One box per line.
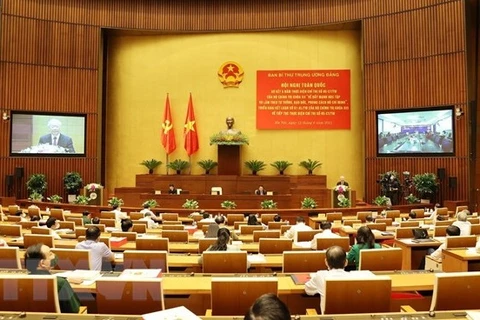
25, 243, 80, 313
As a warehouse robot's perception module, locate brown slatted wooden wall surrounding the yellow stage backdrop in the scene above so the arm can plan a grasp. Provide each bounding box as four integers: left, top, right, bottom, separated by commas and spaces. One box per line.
0, 0, 470, 208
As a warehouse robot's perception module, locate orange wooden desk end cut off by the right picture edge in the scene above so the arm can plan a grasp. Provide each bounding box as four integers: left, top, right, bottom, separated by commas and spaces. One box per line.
442, 248, 480, 272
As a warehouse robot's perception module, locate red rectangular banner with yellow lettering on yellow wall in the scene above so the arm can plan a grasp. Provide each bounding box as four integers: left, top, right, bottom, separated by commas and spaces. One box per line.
257, 70, 350, 129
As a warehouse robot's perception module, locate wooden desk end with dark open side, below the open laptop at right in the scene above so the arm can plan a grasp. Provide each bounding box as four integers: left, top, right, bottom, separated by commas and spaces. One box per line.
394, 239, 442, 270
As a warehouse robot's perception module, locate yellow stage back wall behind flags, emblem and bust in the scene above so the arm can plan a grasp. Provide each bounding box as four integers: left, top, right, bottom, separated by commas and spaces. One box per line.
105, 30, 364, 198
